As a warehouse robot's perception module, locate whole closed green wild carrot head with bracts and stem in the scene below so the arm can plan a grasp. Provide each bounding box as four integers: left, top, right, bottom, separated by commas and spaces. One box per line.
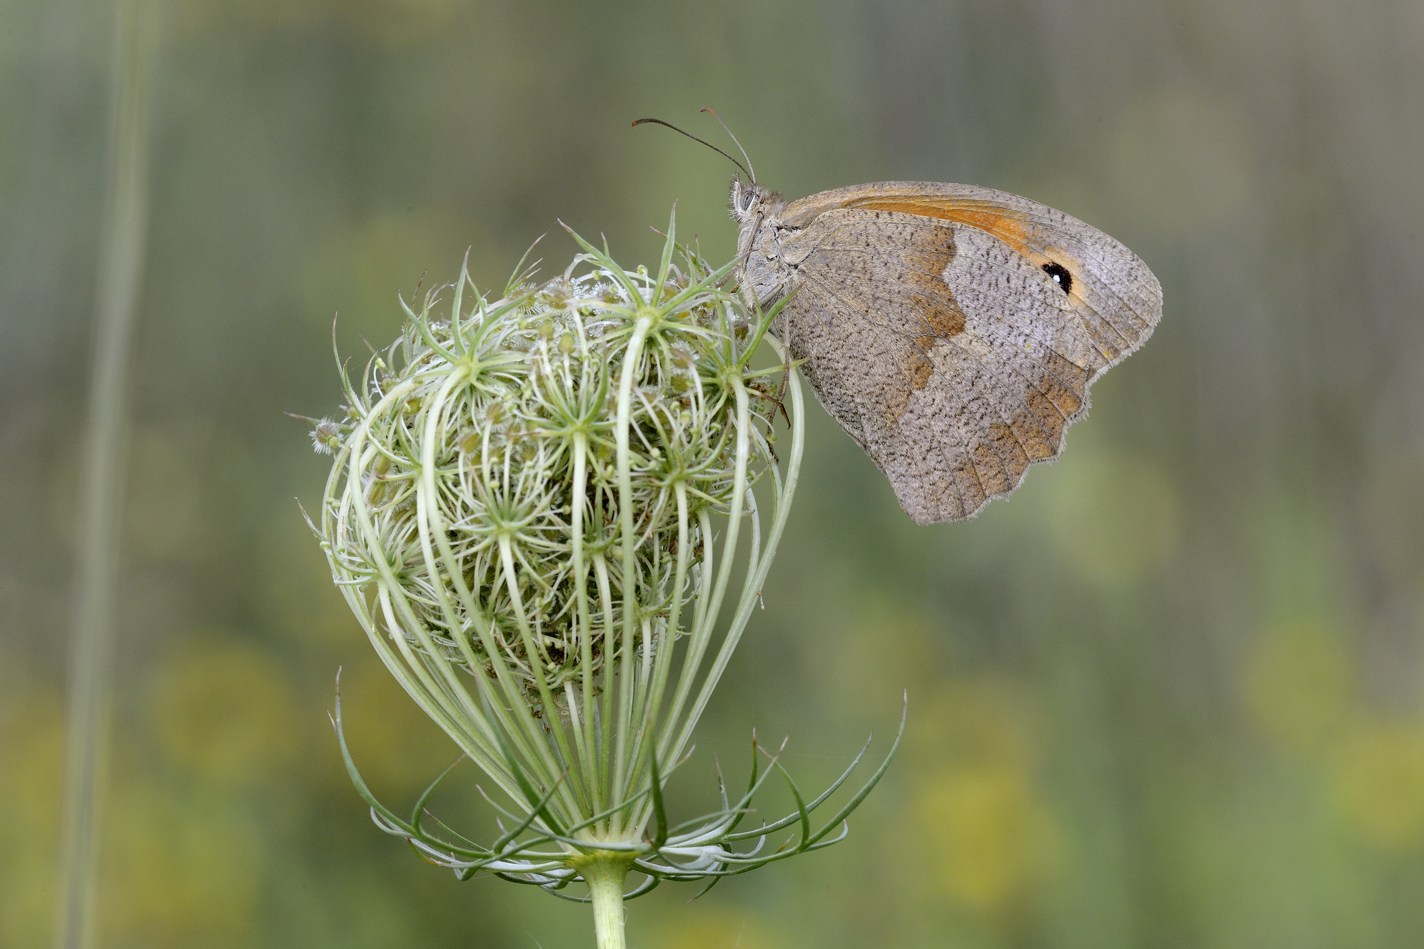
313, 216, 899, 946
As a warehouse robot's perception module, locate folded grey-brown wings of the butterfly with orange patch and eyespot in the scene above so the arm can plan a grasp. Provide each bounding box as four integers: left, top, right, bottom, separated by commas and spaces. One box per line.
748, 182, 1162, 523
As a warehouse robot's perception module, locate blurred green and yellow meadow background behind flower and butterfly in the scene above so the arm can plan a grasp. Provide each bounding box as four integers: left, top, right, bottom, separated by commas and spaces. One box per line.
0, 0, 1424, 949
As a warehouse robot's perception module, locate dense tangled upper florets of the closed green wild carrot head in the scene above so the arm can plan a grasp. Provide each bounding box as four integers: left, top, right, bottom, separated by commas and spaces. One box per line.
313, 232, 775, 701
